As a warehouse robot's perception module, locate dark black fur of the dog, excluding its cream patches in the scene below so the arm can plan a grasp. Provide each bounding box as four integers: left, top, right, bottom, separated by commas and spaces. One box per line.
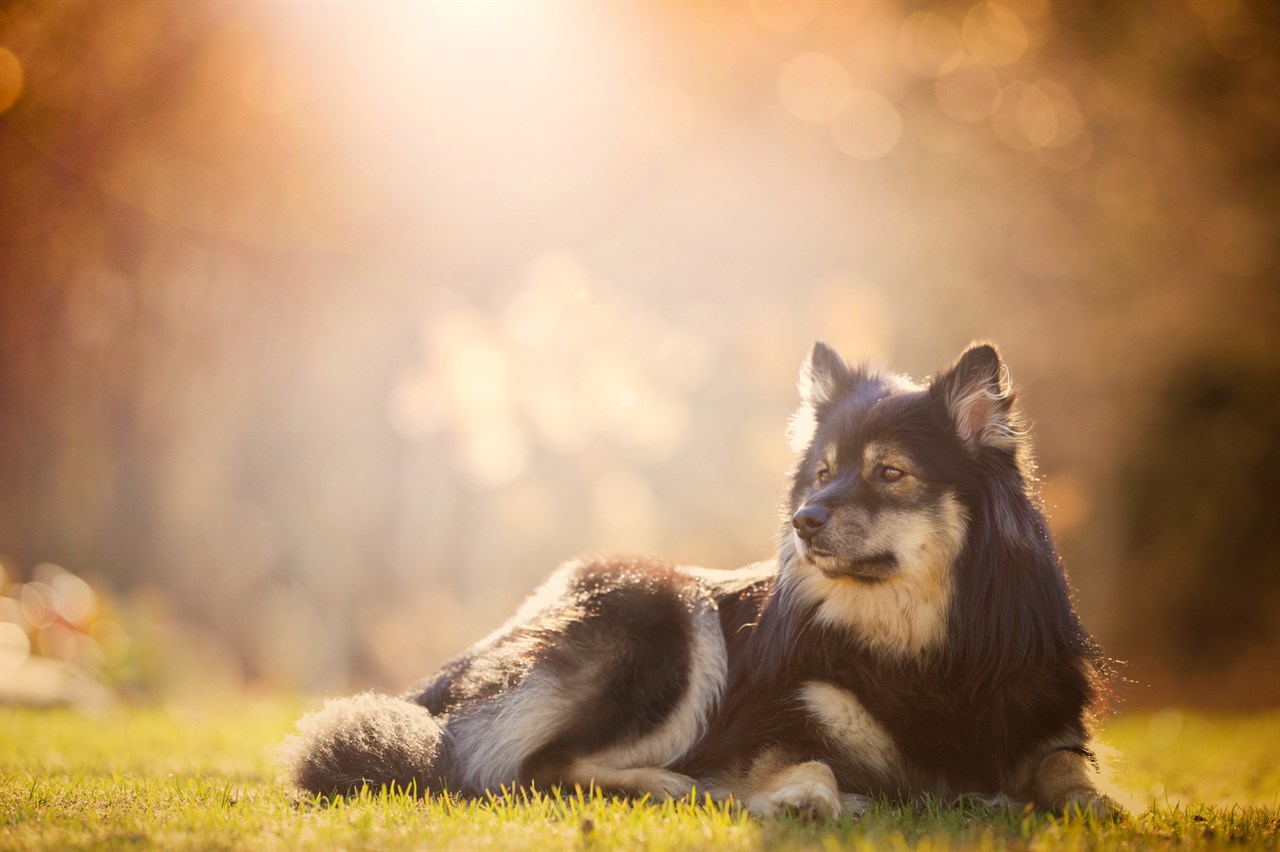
285, 344, 1100, 813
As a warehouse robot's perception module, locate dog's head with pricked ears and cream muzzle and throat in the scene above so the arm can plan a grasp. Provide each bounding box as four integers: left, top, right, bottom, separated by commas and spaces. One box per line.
782, 343, 1023, 651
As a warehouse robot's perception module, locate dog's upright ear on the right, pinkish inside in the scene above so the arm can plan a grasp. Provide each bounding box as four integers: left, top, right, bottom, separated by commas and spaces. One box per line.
929, 343, 1023, 452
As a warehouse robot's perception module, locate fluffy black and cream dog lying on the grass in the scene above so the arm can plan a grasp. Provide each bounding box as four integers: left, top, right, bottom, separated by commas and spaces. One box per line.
282, 343, 1119, 819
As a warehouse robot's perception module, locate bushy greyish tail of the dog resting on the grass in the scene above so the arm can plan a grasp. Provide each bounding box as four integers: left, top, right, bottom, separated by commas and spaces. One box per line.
278, 692, 445, 796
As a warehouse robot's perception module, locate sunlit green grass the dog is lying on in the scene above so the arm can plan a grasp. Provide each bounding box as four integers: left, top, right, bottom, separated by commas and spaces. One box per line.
0, 700, 1280, 852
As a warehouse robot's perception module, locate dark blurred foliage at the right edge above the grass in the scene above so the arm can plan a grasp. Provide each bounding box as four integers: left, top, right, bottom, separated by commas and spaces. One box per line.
1121, 362, 1280, 702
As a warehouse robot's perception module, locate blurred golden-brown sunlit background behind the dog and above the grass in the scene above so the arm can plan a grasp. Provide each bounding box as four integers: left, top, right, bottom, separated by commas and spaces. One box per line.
0, 0, 1280, 707
